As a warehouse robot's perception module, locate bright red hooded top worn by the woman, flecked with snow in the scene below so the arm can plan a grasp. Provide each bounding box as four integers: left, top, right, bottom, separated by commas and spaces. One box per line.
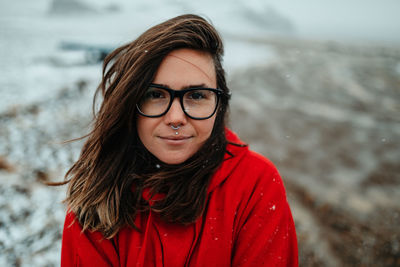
61, 132, 298, 267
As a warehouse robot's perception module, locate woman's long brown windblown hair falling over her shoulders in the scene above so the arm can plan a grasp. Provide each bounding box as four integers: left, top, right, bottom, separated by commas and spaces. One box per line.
59, 14, 229, 238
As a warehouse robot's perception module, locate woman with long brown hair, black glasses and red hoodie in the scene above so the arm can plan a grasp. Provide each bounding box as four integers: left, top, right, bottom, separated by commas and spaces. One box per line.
61, 15, 297, 266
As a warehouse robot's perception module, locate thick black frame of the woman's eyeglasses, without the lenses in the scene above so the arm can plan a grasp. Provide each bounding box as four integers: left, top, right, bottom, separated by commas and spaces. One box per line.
136, 83, 224, 120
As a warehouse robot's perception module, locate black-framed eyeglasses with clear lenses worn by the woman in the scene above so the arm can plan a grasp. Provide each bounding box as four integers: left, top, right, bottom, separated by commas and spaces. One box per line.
136, 84, 224, 120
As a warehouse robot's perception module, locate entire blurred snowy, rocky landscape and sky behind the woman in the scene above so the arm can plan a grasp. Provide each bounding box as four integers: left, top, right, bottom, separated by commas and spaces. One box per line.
0, 0, 400, 266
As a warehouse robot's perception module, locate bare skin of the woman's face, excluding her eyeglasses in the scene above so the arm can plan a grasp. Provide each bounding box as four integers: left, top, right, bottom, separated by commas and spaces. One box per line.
137, 49, 217, 164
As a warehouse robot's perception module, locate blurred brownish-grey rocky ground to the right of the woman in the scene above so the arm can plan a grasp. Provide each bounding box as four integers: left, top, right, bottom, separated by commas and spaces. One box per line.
231, 36, 400, 266
